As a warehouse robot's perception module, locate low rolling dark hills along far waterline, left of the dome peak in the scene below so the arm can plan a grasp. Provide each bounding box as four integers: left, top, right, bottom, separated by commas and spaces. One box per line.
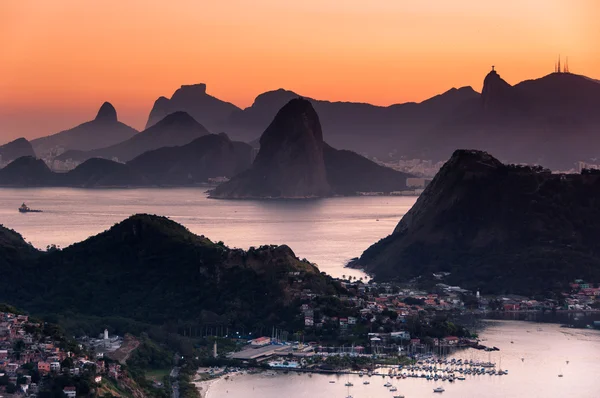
0, 134, 252, 188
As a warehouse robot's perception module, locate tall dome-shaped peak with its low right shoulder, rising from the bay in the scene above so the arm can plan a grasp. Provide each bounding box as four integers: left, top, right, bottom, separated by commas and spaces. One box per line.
211, 98, 409, 199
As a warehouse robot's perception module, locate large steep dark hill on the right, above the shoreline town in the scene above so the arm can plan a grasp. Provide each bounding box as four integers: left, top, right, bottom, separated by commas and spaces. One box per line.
359, 150, 600, 294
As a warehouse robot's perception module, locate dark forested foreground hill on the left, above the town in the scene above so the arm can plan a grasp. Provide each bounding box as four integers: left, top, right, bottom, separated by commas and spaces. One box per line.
0, 215, 344, 332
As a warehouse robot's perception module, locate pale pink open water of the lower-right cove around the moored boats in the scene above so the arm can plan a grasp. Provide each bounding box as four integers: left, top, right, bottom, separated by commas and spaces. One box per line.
208, 321, 600, 398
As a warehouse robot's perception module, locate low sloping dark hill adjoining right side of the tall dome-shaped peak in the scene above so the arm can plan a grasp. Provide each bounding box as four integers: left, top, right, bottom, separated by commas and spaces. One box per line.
323, 144, 410, 195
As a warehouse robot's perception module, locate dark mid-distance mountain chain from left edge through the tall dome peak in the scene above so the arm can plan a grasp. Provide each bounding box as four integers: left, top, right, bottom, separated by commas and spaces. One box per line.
0, 98, 409, 194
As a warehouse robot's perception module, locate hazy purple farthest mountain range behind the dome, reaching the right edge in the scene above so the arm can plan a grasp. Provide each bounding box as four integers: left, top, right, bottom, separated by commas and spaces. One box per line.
148, 70, 600, 169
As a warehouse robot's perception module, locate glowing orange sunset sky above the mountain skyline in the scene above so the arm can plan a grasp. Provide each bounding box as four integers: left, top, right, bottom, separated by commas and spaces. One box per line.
0, 0, 600, 143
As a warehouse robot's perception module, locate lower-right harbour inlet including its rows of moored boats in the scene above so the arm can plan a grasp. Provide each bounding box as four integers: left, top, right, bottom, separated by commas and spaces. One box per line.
208, 321, 600, 398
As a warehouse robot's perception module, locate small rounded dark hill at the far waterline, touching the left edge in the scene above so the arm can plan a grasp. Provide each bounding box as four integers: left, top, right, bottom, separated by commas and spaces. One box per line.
0, 156, 55, 187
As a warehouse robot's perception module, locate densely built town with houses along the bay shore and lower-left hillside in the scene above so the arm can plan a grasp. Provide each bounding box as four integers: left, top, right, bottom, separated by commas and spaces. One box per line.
0, 272, 600, 397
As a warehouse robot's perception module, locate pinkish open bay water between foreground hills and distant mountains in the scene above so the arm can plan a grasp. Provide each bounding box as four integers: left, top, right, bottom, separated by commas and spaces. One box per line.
0, 188, 415, 276
